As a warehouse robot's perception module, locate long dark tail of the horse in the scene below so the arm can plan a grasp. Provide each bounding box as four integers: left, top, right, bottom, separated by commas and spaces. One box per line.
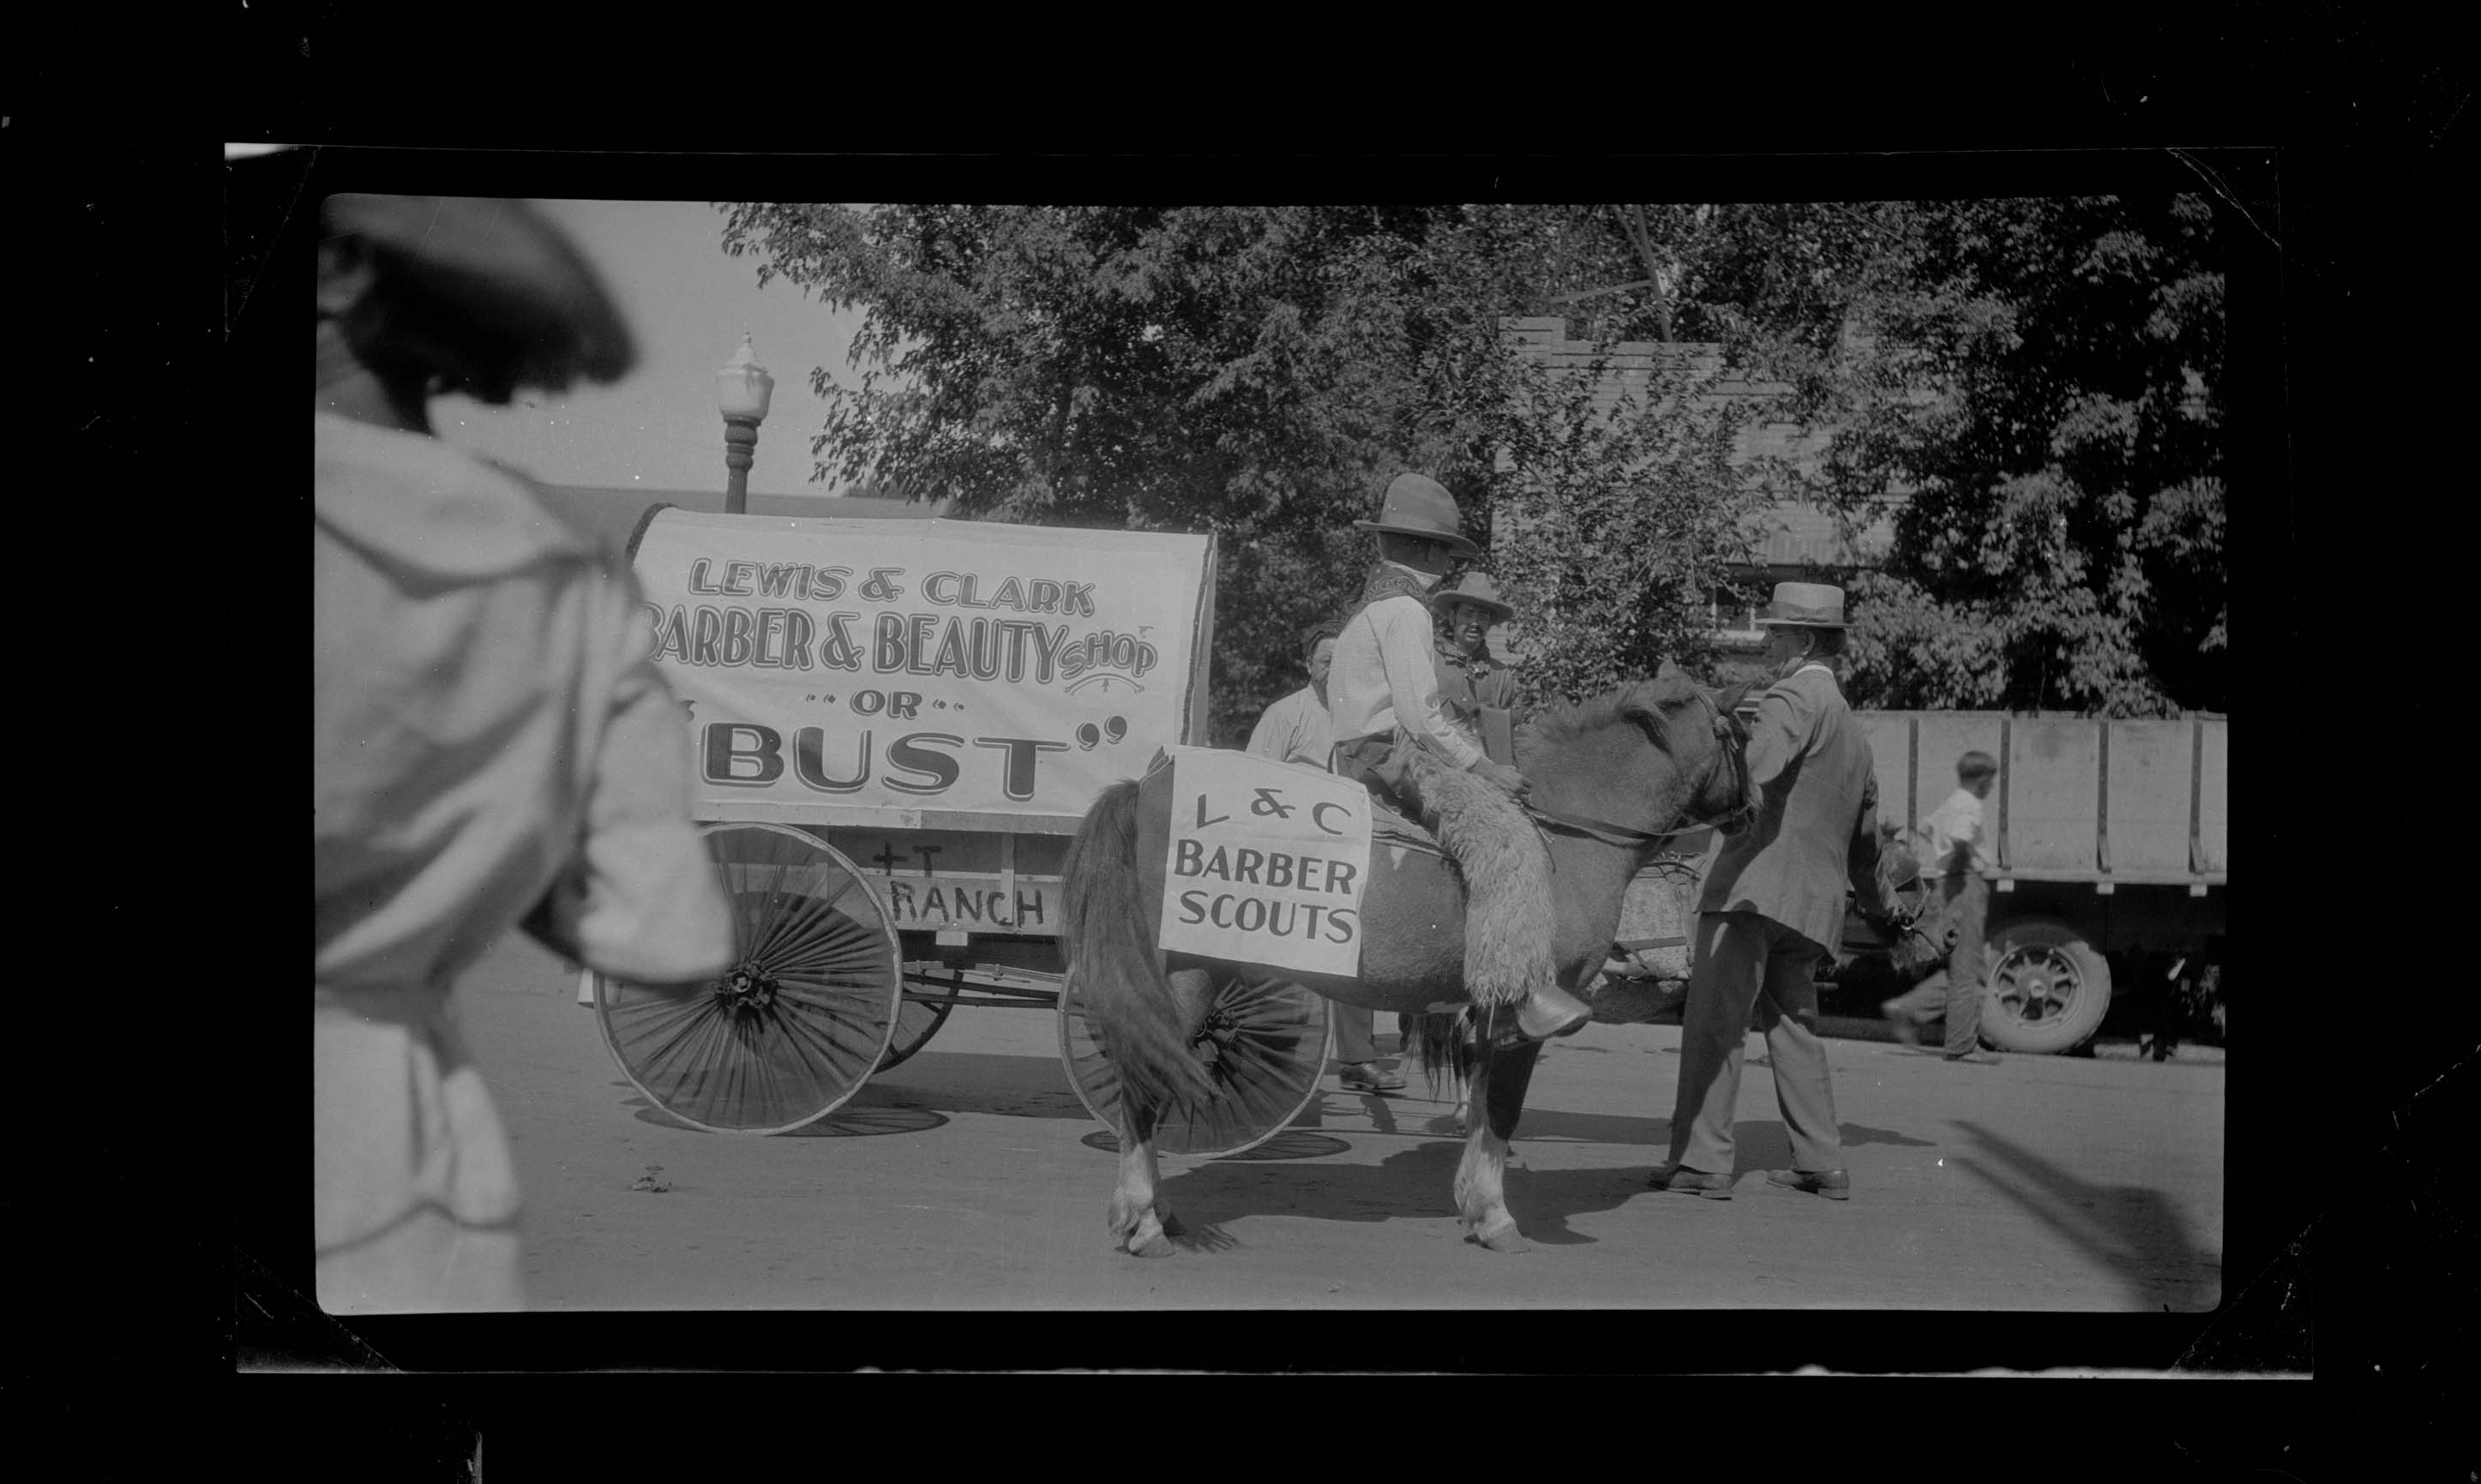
1060, 782, 1213, 1112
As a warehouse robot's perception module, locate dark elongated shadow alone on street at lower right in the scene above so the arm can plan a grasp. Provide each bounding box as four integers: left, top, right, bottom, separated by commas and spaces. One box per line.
1953, 1119, 2223, 1313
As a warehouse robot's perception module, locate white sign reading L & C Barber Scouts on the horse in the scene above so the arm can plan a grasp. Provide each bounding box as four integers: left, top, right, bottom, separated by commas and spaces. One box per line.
1156, 747, 1369, 977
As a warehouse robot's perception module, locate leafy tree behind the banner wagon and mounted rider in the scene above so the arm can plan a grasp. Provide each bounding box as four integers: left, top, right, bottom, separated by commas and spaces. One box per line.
724, 203, 1776, 742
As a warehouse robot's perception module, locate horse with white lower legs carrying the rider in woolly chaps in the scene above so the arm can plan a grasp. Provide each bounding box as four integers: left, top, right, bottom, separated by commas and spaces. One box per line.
1062, 668, 1757, 1259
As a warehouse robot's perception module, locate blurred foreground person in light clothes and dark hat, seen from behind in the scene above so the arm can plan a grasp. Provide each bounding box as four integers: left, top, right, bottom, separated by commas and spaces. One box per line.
310, 196, 732, 1315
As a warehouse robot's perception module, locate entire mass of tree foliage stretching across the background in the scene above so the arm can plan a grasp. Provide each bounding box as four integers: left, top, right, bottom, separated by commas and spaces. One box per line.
724, 196, 2228, 742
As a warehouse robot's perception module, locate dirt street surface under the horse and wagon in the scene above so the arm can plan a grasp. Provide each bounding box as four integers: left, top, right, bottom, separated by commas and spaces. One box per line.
459, 938, 2223, 1313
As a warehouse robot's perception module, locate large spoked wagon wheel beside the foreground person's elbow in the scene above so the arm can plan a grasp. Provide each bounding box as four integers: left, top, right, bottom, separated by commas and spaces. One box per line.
596, 824, 903, 1134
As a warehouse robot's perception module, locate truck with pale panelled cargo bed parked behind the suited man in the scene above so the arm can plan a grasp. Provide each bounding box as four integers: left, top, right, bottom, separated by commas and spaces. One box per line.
1620, 710, 2231, 1057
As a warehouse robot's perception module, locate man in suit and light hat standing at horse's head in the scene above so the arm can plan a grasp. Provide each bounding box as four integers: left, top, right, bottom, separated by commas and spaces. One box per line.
1648, 583, 1885, 1201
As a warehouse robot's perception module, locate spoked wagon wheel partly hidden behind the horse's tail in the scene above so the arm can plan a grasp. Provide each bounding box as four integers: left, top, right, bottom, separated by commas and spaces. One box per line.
1060, 976, 1327, 1159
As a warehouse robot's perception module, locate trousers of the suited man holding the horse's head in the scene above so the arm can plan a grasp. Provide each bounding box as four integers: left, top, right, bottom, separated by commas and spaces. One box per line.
1673, 910, 1843, 1174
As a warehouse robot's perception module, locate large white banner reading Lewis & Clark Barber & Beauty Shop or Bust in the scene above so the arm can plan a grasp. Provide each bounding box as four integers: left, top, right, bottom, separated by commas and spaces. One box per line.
635, 508, 1213, 834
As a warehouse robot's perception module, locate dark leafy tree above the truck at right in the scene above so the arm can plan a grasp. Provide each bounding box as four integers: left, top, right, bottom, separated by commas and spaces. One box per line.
1682, 196, 2228, 718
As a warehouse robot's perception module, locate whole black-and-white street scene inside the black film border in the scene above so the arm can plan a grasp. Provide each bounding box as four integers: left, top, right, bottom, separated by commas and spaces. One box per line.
290, 175, 2262, 1340
